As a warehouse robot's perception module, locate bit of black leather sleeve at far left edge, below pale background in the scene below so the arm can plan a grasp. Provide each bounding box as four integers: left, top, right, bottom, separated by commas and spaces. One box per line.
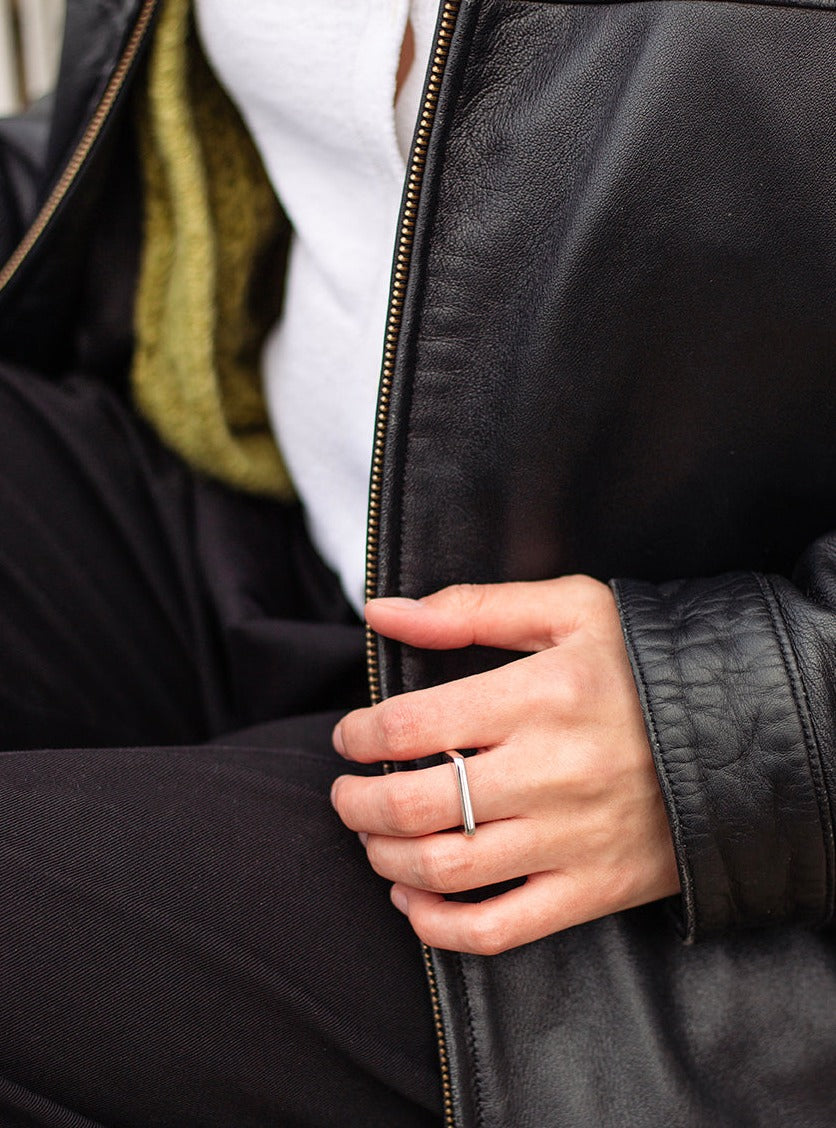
0, 98, 52, 265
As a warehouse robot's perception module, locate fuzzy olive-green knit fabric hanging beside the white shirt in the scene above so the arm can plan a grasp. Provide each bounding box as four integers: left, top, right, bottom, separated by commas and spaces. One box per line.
132, 0, 293, 497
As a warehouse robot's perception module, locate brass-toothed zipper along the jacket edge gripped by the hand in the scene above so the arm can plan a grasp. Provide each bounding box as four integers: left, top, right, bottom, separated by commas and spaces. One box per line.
366, 0, 461, 1128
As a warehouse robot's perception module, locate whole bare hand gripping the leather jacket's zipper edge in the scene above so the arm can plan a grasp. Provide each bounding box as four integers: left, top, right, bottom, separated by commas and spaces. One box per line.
332, 576, 679, 955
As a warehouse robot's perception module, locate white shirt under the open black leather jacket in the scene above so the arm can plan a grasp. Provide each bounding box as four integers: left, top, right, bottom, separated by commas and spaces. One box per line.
195, 0, 438, 609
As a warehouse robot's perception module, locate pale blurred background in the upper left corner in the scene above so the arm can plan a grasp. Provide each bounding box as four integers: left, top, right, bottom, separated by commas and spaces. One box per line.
0, 0, 64, 116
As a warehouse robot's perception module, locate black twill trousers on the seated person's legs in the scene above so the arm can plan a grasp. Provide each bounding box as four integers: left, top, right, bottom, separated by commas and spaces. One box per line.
0, 367, 441, 1128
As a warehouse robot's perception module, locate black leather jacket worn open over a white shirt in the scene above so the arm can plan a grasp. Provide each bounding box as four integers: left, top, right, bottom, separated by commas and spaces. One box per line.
0, 0, 836, 1128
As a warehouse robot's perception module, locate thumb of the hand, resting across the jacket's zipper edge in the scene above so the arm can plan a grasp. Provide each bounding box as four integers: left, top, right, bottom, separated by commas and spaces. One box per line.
366, 576, 611, 651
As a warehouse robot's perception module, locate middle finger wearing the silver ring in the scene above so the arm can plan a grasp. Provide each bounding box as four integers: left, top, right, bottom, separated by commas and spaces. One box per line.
331, 752, 526, 838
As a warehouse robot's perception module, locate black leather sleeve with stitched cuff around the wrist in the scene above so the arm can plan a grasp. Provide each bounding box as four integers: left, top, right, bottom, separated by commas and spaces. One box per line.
613, 534, 836, 942
